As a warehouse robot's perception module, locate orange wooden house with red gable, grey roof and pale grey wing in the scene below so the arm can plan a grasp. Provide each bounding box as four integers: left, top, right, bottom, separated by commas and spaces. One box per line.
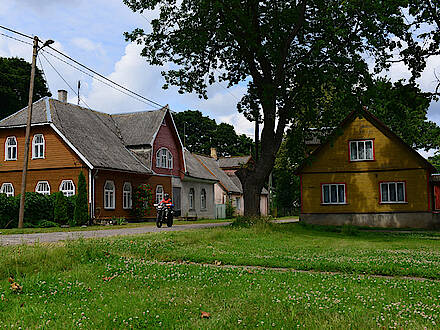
0, 91, 217, 218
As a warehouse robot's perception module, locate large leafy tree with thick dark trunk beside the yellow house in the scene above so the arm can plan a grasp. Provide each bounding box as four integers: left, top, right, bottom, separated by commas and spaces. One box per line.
124, 0, 416, 215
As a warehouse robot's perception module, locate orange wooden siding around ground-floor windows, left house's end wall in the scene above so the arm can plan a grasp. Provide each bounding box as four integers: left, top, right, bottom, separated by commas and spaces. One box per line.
0, 167, 88, 196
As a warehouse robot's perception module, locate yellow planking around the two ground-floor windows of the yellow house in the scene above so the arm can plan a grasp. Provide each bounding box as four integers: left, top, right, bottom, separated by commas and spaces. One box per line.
302, 169, 431, 213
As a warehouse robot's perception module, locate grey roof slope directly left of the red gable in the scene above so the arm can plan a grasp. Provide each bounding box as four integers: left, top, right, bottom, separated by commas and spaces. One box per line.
111, 106, 168, 146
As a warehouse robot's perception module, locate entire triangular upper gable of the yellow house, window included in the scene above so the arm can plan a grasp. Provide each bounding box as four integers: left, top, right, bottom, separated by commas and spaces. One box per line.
300, 115, 427, 173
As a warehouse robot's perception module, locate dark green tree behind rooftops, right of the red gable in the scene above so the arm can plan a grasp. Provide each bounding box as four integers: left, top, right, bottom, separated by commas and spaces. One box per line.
173, 110, 253, 156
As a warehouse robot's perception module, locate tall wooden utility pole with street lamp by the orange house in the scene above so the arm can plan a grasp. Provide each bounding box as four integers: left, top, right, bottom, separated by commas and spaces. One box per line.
18, 36, 53, 228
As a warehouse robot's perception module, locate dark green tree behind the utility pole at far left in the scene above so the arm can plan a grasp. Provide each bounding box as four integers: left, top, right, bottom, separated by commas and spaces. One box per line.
0, 57, 52, 119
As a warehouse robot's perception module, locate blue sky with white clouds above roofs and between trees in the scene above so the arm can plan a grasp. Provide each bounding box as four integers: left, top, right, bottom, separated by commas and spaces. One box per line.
0, 0, 440, 156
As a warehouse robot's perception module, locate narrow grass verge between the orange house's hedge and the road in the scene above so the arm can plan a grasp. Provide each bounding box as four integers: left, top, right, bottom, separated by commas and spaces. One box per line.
0, 219, 229, 235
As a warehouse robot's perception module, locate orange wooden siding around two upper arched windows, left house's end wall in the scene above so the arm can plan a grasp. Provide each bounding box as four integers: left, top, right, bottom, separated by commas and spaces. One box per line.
0, 126, 84, 175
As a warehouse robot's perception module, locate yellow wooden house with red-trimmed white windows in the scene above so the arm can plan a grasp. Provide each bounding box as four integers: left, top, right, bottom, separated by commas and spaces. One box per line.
297, 110, 440, 228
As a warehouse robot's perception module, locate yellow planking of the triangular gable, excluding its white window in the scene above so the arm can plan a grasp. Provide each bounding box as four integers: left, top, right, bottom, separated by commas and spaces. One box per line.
302, 118, 426, 173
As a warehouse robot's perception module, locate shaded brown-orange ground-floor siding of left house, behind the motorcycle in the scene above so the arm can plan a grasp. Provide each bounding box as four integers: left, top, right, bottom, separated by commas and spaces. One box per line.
95, 170, 171, 219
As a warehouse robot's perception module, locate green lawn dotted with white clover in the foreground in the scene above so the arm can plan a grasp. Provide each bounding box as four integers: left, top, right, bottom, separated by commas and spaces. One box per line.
0, 224, 440, 329
